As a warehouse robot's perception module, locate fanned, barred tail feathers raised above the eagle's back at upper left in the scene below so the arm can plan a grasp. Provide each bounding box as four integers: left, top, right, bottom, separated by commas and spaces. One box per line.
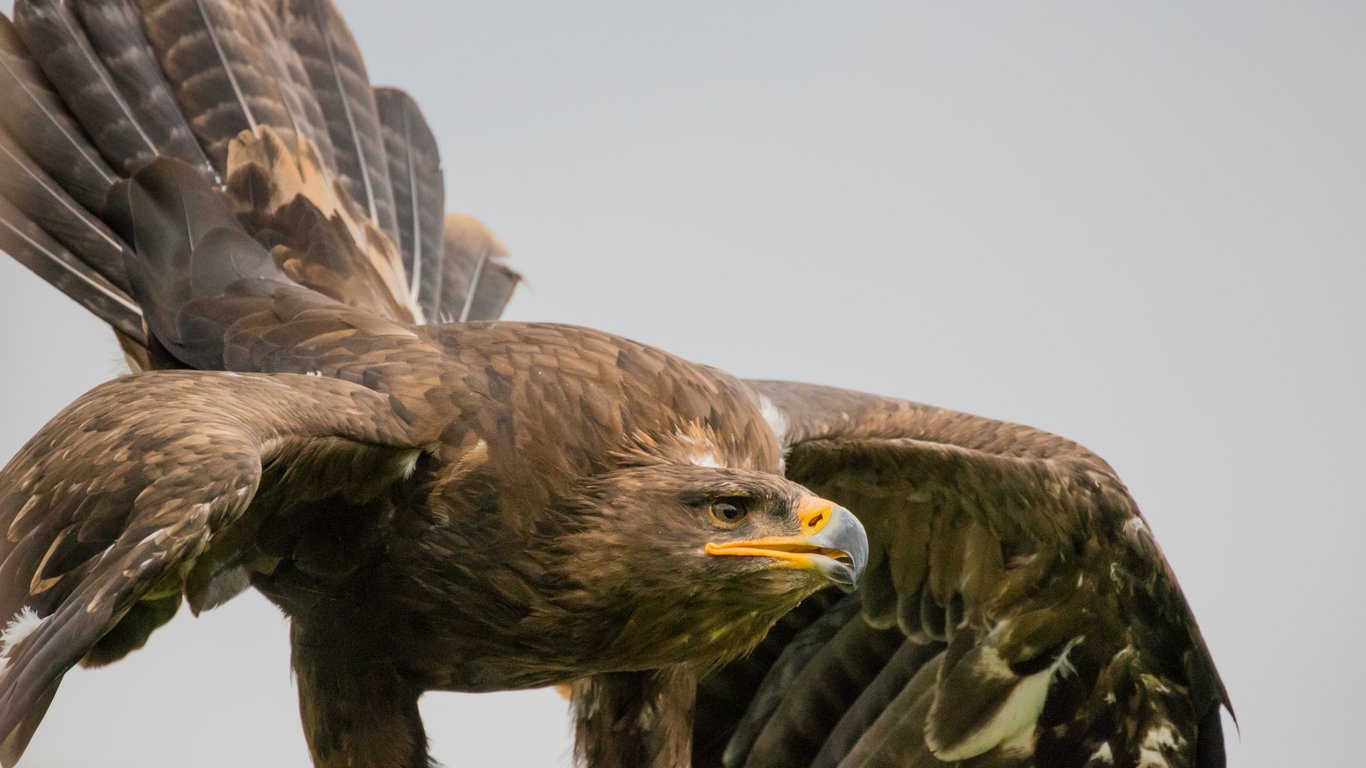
0, 0, 515, 352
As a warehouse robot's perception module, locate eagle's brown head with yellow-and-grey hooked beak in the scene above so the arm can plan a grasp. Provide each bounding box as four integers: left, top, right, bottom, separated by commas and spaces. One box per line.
560, 462, 867, 668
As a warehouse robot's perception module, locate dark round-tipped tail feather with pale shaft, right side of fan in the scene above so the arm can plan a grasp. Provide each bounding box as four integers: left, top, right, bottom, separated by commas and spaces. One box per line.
374, 87, 445, 317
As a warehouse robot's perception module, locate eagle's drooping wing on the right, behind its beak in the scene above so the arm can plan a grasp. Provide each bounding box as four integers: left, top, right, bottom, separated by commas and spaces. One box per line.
695, 381, 1228, 768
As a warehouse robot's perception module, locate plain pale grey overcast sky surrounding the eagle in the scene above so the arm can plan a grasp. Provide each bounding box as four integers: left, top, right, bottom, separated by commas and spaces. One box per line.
0, 0, 1366, 768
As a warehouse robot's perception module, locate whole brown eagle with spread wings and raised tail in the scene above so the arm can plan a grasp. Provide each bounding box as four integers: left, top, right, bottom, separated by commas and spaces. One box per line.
0, 0, 1231, 768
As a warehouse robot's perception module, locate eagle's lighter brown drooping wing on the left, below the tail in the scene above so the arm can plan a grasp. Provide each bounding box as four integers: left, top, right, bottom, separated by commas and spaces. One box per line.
0, 372, 430, 765
